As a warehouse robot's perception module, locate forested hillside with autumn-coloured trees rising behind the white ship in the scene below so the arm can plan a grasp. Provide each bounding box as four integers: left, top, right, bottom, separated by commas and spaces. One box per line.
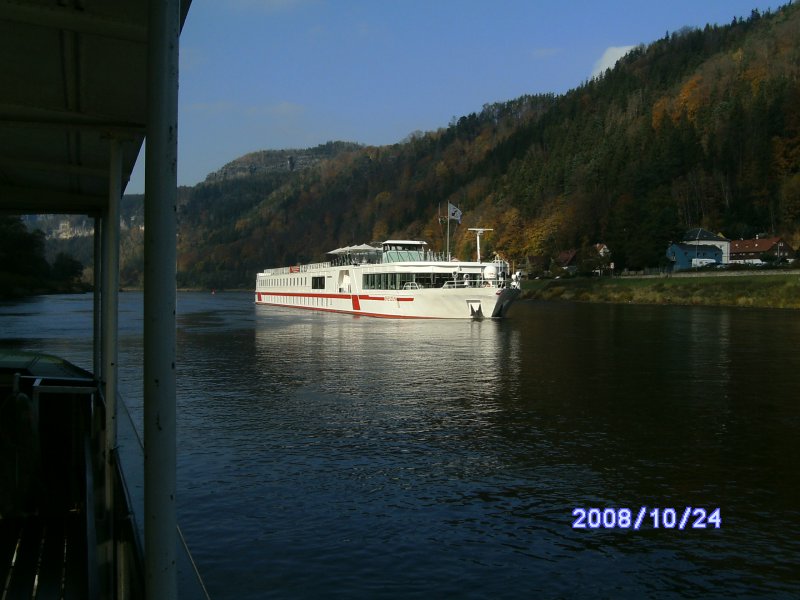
42, 5, 800, 287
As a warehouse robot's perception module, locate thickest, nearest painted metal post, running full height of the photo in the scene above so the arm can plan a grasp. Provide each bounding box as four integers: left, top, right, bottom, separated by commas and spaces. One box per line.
144, 0, 180, 600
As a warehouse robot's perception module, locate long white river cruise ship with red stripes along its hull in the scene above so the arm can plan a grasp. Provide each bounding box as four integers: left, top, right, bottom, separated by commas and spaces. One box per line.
255, 240, 519, 319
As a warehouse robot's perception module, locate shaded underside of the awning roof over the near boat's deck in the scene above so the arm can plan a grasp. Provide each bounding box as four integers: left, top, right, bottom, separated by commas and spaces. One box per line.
0, 0, 190, 214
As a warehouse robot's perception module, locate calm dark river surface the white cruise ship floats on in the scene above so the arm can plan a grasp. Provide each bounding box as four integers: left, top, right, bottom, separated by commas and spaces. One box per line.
0, 293, 800, 599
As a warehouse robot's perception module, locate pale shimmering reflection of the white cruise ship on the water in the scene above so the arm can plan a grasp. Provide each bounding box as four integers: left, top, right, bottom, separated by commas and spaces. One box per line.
255, 306, 520, 414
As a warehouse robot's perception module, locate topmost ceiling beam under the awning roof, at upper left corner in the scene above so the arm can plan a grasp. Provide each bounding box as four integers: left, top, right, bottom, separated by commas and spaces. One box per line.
0, 0, 147, 44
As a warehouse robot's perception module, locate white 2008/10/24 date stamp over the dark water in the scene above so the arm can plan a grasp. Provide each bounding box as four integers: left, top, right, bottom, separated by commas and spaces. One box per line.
572, 506, 722, 531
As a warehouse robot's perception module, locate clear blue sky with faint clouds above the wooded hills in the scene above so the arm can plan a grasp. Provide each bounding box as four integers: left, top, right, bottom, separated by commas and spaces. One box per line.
126, 0, 788, 193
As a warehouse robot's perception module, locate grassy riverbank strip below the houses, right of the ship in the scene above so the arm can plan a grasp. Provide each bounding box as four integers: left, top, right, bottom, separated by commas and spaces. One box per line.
522, 270, 800, 309
